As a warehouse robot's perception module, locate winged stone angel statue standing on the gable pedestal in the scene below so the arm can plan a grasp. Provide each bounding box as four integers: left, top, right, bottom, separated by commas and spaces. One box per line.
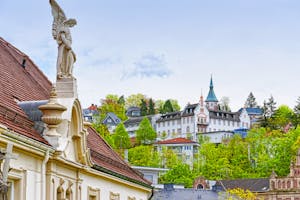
50, 0, 76, 79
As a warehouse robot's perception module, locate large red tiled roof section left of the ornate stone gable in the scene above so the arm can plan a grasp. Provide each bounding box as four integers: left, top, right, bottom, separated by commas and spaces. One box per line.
0, 38, 51, 144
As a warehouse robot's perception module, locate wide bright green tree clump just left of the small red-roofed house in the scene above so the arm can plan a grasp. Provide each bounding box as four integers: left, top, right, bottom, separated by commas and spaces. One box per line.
128, 145, 160, 167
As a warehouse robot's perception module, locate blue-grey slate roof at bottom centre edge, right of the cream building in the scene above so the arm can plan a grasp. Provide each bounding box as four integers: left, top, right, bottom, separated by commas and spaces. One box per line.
151, 189, 218, 200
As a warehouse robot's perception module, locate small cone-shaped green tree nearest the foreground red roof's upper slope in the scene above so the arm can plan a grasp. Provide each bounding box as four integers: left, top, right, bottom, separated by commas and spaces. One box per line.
113, 123, 131, 149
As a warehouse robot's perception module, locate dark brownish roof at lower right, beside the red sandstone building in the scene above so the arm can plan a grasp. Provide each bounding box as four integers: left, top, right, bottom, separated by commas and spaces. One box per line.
216, 178, 269, 192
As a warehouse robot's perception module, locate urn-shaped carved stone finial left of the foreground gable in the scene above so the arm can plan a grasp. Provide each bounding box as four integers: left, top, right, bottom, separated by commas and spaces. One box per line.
39, 86, 67, 137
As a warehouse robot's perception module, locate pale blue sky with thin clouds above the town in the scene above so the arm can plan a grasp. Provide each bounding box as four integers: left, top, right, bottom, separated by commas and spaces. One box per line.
0, 0, 300, 111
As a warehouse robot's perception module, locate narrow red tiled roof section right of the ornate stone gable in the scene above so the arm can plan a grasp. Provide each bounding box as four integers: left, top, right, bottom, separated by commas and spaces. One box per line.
87, 128, 151, 187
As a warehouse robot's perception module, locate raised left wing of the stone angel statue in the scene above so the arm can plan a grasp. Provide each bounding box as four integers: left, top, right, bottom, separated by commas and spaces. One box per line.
49, 0, 67, 39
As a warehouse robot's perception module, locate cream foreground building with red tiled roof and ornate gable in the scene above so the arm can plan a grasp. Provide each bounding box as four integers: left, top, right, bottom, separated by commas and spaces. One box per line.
0, 3, 152, 200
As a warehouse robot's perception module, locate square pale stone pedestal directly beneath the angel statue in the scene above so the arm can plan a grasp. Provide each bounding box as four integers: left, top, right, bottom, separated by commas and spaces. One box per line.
56, 78, 78, 98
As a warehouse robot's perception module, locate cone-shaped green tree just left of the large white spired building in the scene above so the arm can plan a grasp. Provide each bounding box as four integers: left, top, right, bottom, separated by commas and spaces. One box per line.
136, 117, 156, 144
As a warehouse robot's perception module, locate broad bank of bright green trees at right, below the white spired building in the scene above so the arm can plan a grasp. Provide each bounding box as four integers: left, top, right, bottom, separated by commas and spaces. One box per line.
194, 128, 300, 180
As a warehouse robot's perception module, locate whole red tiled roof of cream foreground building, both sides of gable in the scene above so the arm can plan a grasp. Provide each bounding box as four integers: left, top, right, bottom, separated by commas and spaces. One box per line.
0, 37, 151, 187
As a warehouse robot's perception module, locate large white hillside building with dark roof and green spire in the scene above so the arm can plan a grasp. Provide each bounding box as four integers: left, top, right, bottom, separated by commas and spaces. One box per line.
156, 76, 250, 141
